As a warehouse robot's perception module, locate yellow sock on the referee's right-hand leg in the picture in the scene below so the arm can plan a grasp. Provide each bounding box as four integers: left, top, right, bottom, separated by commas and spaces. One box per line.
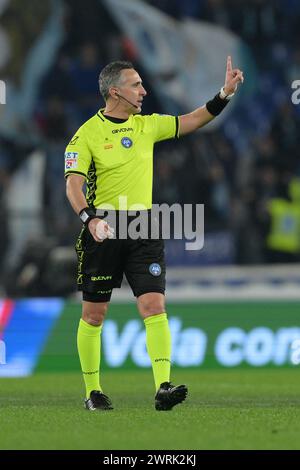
144, 313, 171, 390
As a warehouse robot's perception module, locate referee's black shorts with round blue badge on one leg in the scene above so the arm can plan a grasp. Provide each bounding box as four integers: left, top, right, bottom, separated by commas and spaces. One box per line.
76, 219, 166, 302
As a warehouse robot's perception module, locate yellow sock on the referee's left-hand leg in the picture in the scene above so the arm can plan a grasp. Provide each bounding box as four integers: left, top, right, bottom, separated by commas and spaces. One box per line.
77, 318, 102, 398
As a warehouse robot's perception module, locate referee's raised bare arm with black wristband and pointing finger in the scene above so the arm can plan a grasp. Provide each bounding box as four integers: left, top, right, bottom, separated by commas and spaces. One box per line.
179, 56, 244, 136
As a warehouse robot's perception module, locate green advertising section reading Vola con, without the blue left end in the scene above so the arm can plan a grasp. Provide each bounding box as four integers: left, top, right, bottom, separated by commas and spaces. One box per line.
37, 301, 300, 371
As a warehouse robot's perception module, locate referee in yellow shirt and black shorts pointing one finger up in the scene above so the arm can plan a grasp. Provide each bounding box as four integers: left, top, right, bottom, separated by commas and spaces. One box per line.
65, 57, 243, 411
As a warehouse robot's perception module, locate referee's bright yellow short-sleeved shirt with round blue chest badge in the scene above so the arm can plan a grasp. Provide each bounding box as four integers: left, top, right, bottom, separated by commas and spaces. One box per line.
65, 110, 178, 210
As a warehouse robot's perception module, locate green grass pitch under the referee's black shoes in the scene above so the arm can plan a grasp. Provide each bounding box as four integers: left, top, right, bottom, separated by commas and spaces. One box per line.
0, 369, 300, 450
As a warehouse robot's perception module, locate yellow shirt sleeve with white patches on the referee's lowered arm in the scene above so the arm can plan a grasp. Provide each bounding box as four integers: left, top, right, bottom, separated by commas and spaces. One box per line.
65, 127, 92, 178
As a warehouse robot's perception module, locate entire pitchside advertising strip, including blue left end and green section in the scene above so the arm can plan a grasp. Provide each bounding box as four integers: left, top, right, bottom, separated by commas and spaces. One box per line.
0, 299, 300, 377
